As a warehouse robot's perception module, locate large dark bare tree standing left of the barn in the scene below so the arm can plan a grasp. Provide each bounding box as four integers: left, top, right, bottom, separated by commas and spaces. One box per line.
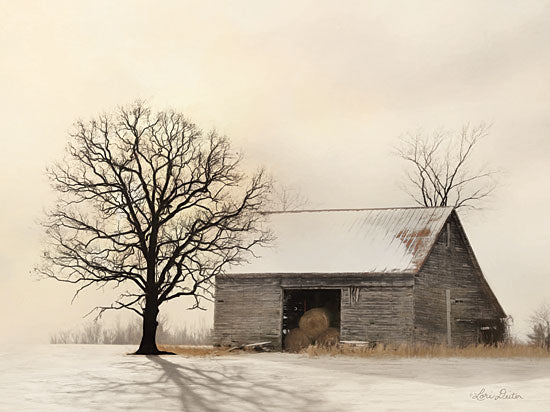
36, 102, 271, 354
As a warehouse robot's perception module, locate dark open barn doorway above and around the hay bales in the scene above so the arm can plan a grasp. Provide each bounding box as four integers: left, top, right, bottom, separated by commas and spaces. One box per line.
282, 289, 341, 350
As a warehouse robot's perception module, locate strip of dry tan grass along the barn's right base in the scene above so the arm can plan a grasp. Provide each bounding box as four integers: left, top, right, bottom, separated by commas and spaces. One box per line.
303, 344, 550, 358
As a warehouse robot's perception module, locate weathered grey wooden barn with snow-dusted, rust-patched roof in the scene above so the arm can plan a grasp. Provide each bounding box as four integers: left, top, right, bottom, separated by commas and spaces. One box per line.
213, 207, 506, 350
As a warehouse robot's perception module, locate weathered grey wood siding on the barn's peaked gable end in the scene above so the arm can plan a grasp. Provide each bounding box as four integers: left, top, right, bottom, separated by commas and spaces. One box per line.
414, 214, 500, 345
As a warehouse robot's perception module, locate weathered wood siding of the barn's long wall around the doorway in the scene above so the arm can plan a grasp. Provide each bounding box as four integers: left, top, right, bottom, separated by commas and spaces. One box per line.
214, 274, 413, 348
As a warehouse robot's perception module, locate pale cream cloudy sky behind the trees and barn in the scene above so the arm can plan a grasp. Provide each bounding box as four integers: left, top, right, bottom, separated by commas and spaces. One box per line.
0, 0, 550, 342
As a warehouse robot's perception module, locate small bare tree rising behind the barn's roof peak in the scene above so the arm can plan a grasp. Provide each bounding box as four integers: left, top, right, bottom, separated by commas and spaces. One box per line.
397, 123, 497, 208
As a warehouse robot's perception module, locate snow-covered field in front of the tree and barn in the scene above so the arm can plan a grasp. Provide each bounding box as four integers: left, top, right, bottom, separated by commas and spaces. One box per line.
0, 345, 550, 412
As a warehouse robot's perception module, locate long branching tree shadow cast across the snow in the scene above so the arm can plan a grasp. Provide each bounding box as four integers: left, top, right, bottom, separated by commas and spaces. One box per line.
58, 356, 324, 412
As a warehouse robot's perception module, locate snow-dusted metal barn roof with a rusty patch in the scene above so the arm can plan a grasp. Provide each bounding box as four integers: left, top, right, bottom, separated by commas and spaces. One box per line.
229, 207, 453, 274
